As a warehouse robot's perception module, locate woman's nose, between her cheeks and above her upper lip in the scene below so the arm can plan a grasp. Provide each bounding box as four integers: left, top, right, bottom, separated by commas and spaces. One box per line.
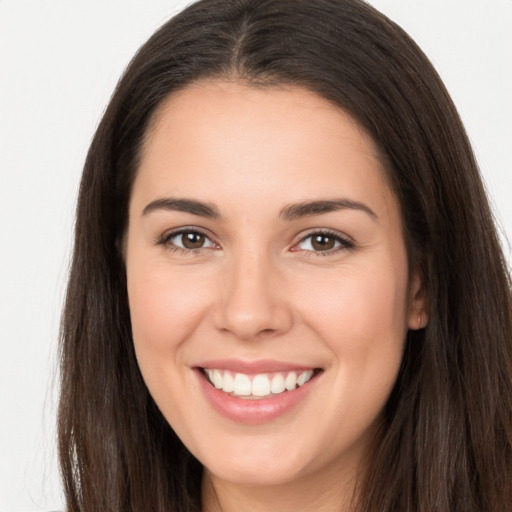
214, 249, 293, 340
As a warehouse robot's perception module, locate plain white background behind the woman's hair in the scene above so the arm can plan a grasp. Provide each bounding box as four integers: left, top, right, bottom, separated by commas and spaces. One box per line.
0, 0, 512, 512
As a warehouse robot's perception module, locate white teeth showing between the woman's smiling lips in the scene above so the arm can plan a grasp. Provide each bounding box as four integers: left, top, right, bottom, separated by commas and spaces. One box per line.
201, 368, 322, 400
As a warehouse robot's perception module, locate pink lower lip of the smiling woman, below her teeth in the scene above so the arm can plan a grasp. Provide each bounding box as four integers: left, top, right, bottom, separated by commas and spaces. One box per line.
196, 369, 318, 425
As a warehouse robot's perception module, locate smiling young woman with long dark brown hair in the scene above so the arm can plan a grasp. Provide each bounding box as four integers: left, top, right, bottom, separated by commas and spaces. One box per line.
59, 0, 512, 512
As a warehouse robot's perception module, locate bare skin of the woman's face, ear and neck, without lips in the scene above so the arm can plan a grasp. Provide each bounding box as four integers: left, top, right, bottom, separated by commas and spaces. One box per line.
125, 81, 426, 511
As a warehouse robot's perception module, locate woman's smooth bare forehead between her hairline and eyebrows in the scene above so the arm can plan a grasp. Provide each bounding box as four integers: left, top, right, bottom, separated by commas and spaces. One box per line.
134, 81, 391, 218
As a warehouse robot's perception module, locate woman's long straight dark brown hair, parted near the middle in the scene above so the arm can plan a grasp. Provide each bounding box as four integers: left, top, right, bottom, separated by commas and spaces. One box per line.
59, 0, 512, 512
